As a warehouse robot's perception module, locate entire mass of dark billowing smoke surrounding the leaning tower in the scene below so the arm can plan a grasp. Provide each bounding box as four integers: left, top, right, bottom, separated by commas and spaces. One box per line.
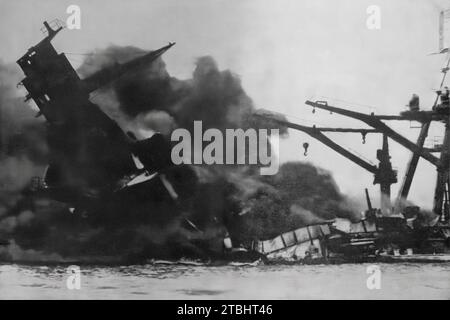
0, 46, 354, 262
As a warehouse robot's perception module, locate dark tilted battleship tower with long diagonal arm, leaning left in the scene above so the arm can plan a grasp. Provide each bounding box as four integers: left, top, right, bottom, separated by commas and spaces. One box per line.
17, 21, 183, 220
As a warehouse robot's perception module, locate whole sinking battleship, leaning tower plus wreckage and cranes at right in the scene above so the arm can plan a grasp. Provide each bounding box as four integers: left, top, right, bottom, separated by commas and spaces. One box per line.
0, 16, 450, 263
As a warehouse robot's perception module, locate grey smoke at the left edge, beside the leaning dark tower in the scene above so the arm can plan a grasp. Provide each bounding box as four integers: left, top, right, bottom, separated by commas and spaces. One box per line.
0, 61, 52, 258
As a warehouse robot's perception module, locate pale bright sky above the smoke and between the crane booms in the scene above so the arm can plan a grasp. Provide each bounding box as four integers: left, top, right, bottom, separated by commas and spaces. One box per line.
0, 0, 450, 208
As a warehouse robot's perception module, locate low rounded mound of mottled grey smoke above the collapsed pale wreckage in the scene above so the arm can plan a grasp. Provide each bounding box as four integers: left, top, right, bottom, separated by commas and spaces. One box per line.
229, 162, 358, 242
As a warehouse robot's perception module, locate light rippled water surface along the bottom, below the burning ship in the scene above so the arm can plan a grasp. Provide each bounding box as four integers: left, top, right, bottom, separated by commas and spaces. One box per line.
0, 263, 450, 299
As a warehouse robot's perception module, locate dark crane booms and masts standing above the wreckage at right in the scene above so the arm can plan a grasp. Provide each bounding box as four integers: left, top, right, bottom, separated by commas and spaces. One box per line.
256, 10, 450, 221
